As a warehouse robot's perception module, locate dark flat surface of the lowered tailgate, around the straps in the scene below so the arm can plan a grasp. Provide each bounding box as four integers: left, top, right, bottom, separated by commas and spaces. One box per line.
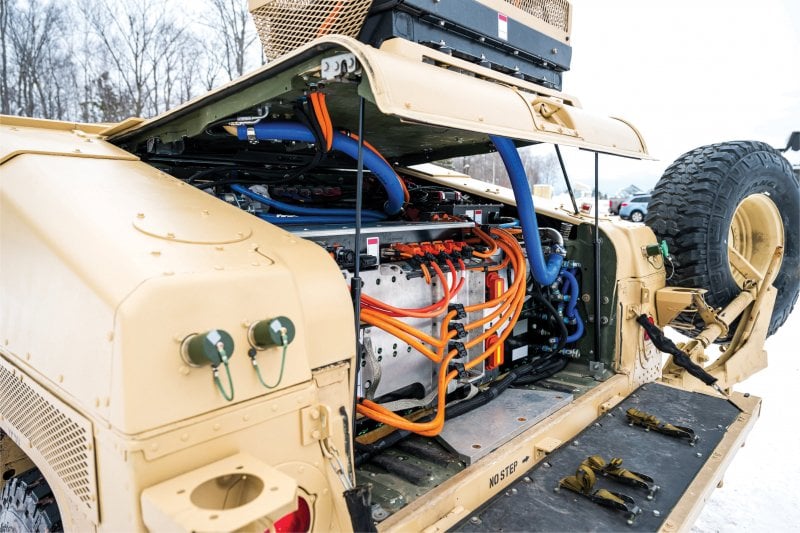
455, 383, 739, 531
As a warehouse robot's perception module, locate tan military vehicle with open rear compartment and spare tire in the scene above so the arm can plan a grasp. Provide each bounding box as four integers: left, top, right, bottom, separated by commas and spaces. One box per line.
0, 0, 800, 533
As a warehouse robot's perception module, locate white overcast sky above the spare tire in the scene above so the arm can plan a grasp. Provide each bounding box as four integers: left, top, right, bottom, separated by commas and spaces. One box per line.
564, 0, 800, 192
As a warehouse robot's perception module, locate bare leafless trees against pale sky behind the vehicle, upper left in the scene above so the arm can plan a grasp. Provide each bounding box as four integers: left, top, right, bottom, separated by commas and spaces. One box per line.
0, 0, 263, 121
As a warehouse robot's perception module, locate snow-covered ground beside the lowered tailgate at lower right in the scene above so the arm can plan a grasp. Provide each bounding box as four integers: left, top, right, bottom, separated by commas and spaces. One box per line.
692, 306, 800, 533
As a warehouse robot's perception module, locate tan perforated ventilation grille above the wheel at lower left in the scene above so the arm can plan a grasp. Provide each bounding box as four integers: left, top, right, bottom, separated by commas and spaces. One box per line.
0, 359, 98, 521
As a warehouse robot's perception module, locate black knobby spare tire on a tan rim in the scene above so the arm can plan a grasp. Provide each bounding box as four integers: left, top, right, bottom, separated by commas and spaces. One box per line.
645, 141, 800, 343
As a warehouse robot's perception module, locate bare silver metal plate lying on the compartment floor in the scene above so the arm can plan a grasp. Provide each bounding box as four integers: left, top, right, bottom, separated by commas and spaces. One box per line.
439, 389, 572, 465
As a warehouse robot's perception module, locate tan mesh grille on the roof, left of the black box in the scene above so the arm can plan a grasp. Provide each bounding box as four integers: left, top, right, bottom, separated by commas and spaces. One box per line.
251, 0, 372, 59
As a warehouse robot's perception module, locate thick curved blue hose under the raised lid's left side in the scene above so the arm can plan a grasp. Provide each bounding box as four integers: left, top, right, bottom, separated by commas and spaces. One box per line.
236, 121, 405, 218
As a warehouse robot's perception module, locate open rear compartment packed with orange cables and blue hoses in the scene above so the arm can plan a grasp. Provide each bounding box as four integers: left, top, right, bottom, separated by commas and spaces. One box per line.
136, 102, 613, 520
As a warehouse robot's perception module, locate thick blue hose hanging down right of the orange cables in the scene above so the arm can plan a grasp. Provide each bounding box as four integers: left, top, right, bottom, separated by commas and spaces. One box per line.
489, 135, 564, 285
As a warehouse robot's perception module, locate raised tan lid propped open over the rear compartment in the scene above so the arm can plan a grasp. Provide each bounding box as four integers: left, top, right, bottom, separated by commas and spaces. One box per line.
111, 36, 649, 165
